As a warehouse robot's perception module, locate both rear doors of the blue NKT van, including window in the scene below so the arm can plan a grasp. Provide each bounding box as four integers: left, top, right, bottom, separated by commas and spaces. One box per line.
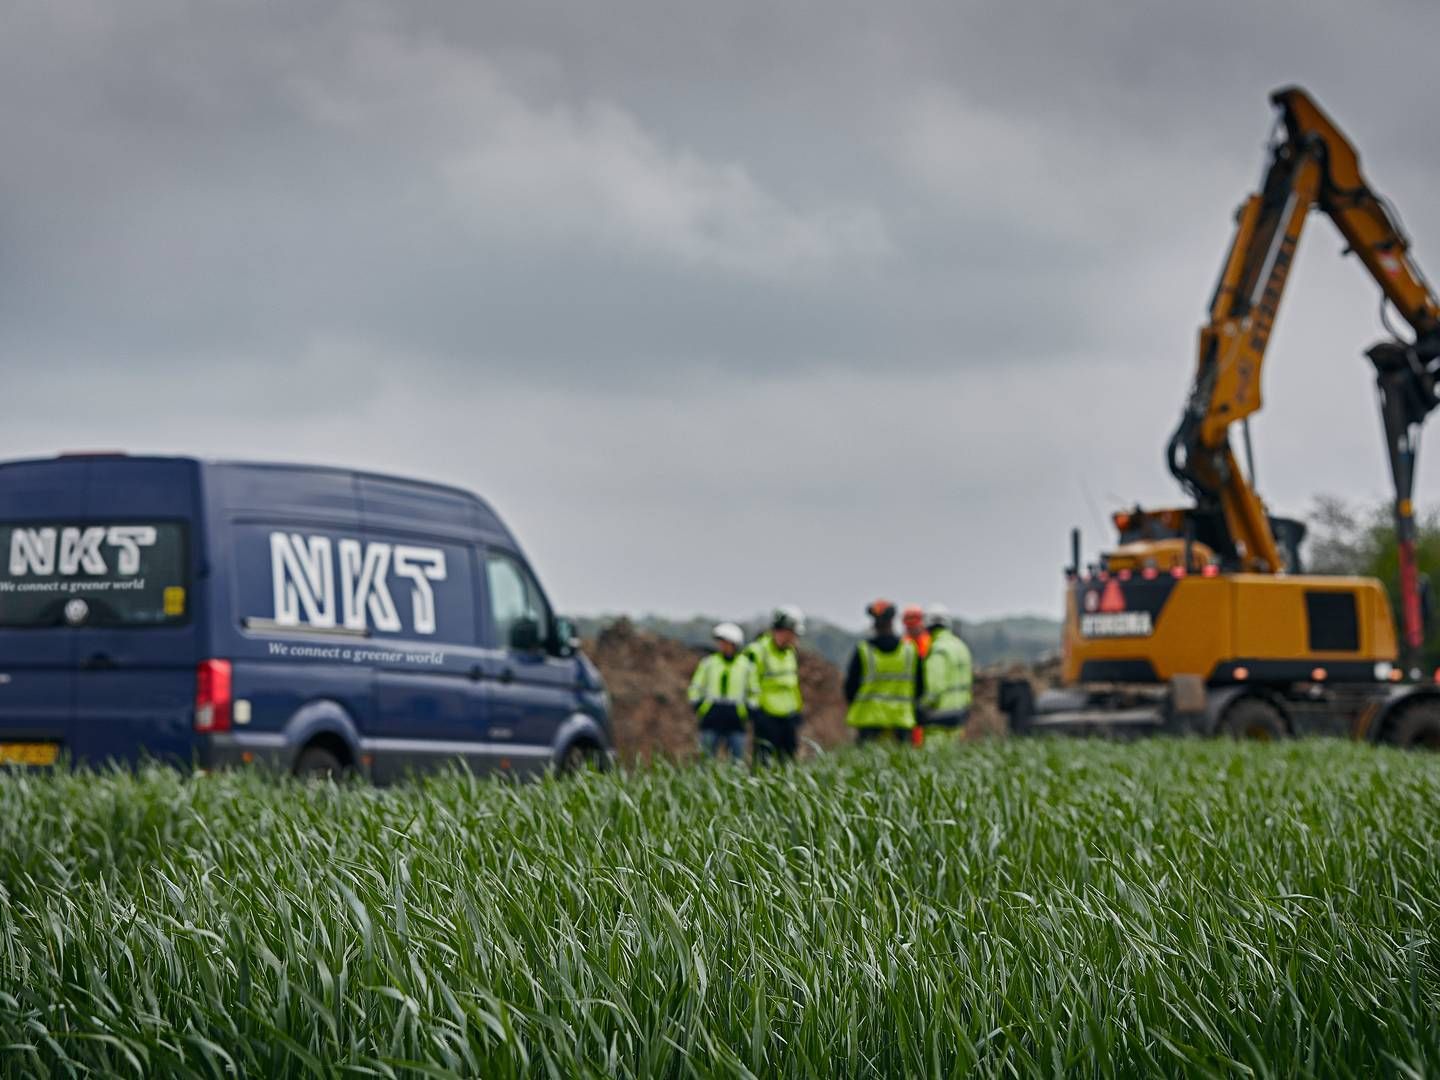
0, 456, 202, 765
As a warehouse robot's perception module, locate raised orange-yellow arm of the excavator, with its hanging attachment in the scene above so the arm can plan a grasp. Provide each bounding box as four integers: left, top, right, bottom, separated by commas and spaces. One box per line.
1168, 88, 1440, 624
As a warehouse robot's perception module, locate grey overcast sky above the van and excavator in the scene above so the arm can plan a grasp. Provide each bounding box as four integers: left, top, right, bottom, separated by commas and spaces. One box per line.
0, 0, 1440, 624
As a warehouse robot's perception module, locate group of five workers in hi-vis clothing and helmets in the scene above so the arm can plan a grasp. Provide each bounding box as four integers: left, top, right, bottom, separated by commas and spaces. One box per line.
690, 599, 973, 766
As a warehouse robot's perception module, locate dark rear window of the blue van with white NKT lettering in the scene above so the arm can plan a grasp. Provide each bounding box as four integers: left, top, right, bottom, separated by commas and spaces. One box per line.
0, 521, 189, 628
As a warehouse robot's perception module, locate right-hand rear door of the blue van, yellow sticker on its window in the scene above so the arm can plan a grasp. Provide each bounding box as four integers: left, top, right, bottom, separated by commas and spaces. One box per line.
71, 458, 203, 763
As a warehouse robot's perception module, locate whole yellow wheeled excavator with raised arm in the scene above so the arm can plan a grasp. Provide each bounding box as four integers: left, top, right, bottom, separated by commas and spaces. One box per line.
1001, 88, 1440, 749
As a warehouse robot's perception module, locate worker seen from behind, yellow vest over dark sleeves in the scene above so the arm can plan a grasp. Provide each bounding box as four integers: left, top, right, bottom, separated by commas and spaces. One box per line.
845, 600, 924, 744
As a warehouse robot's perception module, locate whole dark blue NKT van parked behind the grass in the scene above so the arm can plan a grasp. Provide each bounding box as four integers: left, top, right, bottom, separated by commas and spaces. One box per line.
0, 454, 612, 782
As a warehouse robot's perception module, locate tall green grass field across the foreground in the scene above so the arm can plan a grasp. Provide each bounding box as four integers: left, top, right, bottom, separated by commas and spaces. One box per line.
0, 742, 1440, 1077
